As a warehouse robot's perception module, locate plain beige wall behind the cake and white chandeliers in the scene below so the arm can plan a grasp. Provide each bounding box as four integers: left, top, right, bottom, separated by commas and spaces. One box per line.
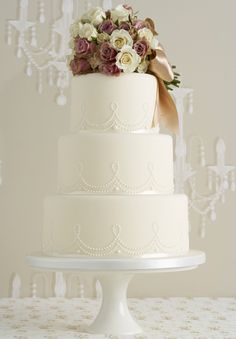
0, 0, 236, 297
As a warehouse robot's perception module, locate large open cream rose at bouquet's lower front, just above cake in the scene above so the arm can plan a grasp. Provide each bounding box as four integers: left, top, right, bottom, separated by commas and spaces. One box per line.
116, 46, 141, 73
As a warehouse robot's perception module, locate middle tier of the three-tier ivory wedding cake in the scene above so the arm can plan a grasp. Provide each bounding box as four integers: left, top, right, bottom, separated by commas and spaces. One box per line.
58, 132, 173, 194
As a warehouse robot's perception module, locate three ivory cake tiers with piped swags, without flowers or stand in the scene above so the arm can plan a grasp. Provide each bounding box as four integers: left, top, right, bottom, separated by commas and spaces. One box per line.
43, 73, 189, 257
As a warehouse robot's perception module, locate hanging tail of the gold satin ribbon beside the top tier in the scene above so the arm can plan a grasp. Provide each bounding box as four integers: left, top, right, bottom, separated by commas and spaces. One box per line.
153, 77, 179, 134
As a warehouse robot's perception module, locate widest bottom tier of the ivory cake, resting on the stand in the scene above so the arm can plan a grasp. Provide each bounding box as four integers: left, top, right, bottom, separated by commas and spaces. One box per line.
42, 194, 189, 257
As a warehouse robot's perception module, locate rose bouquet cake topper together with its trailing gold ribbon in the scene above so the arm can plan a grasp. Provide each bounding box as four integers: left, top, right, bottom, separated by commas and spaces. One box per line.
68, 4, 180, 131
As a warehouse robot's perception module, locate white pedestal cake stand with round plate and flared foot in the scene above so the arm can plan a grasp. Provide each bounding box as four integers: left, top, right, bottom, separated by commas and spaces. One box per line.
27, 250, 205, 335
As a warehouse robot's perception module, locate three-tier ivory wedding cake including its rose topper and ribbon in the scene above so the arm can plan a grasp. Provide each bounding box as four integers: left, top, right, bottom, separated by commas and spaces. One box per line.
43, 5, 189, 257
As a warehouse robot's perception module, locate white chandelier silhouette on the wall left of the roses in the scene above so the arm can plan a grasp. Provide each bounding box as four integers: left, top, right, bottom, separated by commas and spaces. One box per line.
7, 0, 112, 106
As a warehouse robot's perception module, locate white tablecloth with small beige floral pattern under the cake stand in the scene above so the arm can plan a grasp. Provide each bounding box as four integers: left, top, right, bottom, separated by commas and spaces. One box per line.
0, 298, 236, 339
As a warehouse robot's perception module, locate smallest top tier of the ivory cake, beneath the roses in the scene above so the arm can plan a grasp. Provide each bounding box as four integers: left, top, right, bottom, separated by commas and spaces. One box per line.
70, 73, 158, 132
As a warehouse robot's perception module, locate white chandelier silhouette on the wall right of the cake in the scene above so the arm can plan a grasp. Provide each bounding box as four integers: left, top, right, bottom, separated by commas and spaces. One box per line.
173, 88, 236, 238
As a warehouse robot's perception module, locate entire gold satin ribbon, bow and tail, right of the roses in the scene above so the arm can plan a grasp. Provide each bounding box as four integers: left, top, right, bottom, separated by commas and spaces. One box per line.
148, 44, 179, 134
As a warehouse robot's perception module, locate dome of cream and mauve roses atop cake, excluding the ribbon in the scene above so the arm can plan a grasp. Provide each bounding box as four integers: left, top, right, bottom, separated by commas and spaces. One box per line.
69, 5, 178, 90
